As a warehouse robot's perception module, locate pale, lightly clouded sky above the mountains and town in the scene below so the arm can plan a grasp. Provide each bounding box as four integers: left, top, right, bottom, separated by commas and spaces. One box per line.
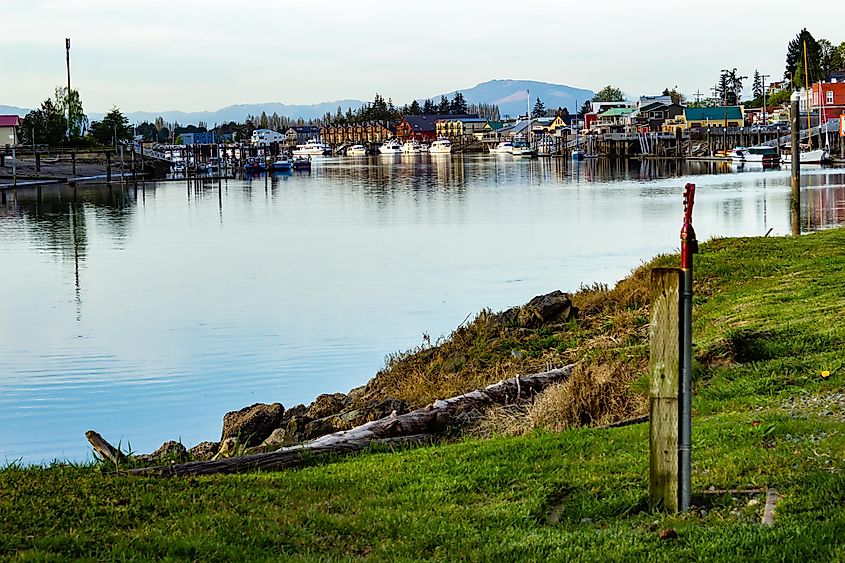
0, 0, 845, 112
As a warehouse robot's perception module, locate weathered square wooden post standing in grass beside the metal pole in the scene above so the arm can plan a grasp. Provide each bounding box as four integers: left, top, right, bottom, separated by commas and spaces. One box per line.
649, 268, 682, 513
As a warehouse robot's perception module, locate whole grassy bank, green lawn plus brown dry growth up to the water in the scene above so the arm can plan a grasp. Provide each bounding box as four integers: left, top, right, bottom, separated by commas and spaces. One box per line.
0, 228, 845, 561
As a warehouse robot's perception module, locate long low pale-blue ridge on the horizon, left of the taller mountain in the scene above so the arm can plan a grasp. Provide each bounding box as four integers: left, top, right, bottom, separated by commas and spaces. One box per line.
88, 100, 364, 126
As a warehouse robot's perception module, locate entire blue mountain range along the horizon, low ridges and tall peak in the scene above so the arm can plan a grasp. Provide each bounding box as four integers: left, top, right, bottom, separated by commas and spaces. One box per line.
8, 80, 594, 125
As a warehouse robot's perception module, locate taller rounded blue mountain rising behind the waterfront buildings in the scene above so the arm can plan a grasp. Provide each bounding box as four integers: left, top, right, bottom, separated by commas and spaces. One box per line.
420, 80, 595, 117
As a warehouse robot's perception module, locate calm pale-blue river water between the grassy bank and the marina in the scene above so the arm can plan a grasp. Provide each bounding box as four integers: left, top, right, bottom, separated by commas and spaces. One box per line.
0, 155, 845, 463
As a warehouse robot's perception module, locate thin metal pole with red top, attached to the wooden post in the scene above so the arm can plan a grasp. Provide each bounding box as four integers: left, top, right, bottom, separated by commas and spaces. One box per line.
678, 184, 698, 512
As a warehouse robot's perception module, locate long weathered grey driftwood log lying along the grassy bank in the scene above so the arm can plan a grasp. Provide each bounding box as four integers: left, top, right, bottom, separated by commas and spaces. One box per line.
129, 364, 574, 476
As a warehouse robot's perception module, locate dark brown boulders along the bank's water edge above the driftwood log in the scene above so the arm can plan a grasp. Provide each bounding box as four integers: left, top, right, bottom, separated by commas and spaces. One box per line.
134, 290, 578, 462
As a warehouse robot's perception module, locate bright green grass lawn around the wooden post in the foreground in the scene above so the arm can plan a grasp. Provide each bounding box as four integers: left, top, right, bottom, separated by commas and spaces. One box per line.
0, 229, 845, 561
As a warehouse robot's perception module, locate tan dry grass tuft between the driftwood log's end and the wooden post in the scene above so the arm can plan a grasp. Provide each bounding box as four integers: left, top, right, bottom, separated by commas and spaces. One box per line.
529, 361, 646, 431
